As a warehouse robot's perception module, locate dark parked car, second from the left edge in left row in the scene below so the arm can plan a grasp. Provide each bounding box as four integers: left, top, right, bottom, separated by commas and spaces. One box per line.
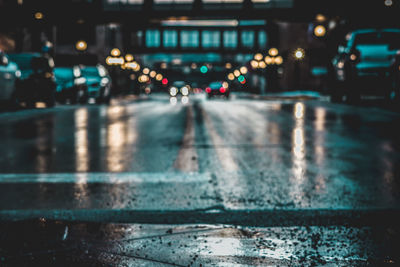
9, 53, 56, 107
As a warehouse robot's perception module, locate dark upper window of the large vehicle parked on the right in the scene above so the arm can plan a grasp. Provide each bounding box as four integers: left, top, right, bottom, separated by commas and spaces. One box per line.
354, 32, 400, 47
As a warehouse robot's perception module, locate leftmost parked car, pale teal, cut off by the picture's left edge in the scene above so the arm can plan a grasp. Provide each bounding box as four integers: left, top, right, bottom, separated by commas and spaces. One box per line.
0, 52, 21, 107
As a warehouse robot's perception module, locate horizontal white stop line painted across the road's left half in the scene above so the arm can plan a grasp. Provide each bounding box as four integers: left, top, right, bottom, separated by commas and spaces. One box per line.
0, 172, 211, 184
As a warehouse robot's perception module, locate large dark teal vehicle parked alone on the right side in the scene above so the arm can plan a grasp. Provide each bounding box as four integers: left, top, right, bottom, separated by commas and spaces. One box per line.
330, 29, 400, 102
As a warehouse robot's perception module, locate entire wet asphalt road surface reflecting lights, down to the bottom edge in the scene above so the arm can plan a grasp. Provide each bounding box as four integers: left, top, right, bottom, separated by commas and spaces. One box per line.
0, 95, 400, 266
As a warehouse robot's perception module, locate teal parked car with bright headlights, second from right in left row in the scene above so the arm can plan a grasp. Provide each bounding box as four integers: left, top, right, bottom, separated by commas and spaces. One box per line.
54, 66, 88, 104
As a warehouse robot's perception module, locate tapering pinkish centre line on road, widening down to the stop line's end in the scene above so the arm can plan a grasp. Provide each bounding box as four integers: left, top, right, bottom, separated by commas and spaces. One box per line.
174, 105, 199, 172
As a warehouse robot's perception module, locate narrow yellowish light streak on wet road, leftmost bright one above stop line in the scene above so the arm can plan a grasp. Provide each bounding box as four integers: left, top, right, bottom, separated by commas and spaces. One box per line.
75, 108, 90, 172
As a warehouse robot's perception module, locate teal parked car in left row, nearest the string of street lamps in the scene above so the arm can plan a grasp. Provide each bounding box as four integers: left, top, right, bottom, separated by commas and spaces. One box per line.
81, 65, 111, 103
